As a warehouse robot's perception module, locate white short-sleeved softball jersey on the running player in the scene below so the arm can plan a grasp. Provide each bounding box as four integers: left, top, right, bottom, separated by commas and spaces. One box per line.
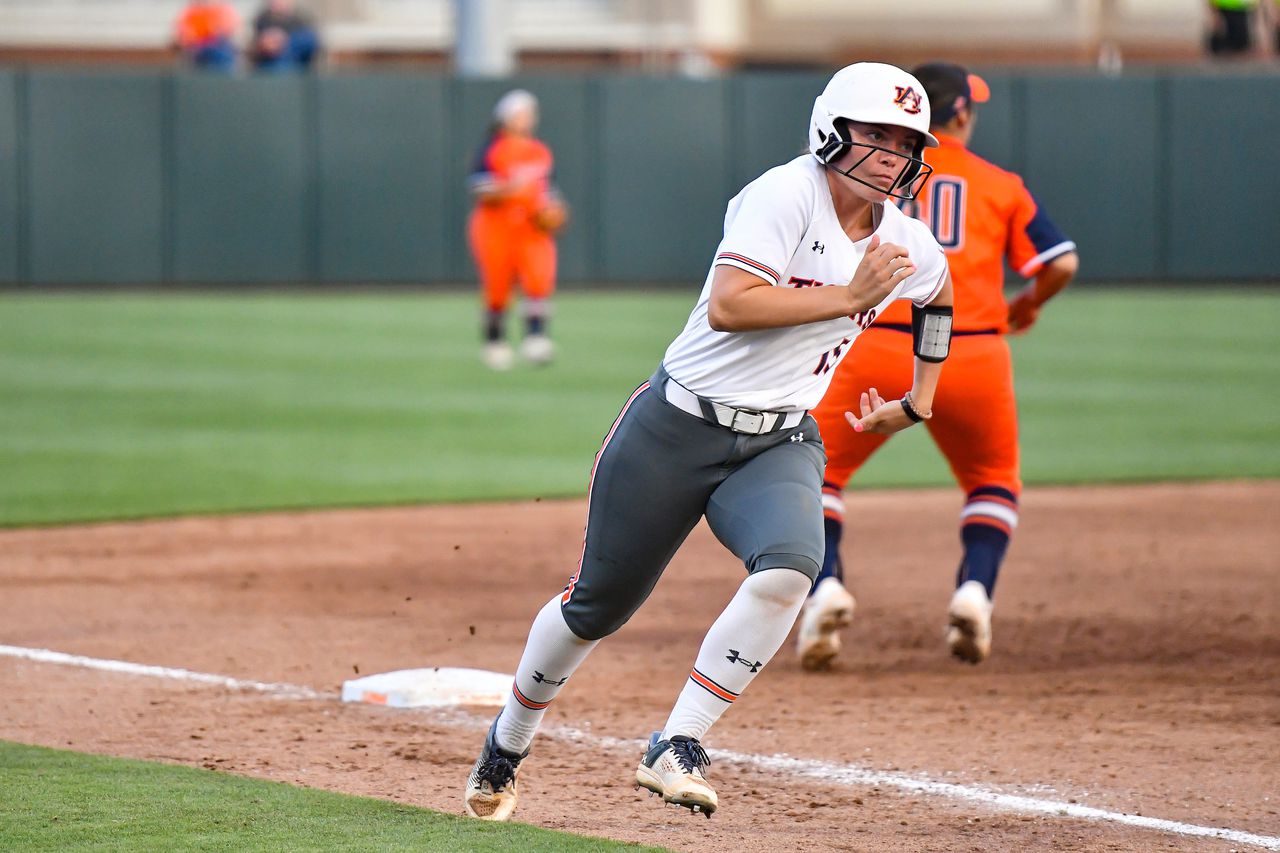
663, 154, 947, 411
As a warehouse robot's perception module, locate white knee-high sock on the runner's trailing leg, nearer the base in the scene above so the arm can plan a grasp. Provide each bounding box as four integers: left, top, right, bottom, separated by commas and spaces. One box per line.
494, 593, 600, 752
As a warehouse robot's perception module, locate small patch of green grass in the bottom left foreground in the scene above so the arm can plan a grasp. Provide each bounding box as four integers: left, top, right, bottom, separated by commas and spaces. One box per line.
0, 742, 662, 853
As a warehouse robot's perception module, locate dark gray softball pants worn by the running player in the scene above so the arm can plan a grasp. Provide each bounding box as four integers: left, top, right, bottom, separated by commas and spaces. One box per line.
561, 368, 827, 640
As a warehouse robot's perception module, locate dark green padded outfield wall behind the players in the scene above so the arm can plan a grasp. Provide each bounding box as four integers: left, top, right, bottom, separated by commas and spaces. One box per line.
0, 68, 1280, 286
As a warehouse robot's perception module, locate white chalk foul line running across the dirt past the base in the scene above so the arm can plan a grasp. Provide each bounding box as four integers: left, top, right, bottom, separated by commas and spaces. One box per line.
0, 646, 1280, 850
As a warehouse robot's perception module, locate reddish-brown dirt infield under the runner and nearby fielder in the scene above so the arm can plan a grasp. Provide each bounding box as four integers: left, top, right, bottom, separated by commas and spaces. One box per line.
0, 482, 1280, 853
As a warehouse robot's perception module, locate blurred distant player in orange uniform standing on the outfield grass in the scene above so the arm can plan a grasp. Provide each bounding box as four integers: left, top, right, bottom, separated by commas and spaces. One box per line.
468, 88, 567, 370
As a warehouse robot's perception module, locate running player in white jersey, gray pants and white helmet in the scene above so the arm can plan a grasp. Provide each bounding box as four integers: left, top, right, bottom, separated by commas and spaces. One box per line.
465, 63, 951, 820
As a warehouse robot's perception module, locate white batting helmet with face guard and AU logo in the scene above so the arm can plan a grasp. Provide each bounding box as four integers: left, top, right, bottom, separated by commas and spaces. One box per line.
809, 63, 938, 199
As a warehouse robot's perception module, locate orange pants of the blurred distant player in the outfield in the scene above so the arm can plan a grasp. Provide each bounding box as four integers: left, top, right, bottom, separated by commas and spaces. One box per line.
467, 210, 556, 311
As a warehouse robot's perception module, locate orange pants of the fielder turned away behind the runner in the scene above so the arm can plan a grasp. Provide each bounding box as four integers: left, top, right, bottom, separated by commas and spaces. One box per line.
813, 327, 1021, 496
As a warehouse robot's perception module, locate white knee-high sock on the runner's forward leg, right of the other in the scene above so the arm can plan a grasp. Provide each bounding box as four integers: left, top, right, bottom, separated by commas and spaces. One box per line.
662, 569, 812, 740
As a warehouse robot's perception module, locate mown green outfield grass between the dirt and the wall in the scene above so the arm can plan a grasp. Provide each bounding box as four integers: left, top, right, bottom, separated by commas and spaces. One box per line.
0, 287, 1280, 525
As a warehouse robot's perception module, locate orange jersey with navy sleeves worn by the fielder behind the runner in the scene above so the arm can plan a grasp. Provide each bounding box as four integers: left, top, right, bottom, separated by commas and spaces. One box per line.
877, 133, 1075, 332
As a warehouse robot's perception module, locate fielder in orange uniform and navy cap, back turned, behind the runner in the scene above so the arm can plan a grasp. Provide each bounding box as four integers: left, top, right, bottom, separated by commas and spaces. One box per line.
797, 63, 1078, 669
